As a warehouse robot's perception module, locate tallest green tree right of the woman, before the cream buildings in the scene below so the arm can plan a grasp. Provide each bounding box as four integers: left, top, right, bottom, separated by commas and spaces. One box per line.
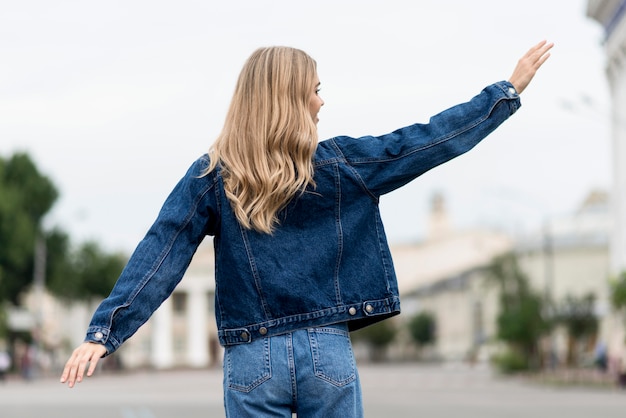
487, 253, 550, 369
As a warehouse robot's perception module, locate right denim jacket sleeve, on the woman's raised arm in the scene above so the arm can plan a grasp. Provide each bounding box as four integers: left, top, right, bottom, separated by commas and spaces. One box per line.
330, 81, 521, 198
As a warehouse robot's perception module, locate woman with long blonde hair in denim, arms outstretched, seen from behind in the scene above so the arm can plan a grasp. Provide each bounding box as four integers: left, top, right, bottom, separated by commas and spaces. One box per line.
61, 41, 552, 418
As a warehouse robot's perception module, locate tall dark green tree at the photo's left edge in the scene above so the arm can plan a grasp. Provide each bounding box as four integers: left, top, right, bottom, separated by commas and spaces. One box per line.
0, 153, 58, 304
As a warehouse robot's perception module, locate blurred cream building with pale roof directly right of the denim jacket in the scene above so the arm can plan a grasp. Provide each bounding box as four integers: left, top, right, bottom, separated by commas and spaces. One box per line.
391, 195, 514, 361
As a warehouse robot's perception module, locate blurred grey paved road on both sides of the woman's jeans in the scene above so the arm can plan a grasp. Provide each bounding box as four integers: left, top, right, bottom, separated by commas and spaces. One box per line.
0, 365, 626, 418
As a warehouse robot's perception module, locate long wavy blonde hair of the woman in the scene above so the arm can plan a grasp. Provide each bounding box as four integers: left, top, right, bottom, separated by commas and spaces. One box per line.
207, 47, 318, 233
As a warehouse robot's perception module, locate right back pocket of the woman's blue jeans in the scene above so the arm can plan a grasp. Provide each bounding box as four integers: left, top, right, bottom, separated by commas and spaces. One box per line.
309, 327, 356, 386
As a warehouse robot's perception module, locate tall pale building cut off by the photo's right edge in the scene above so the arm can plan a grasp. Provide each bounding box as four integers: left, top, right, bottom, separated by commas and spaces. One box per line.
587, 0, 626, 274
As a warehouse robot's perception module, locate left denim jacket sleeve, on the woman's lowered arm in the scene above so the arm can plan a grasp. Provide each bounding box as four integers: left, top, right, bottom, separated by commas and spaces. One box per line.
85, 156, 217, 354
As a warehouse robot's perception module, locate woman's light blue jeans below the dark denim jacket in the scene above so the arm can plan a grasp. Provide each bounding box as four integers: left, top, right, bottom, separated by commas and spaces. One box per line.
224, 324, 363, 418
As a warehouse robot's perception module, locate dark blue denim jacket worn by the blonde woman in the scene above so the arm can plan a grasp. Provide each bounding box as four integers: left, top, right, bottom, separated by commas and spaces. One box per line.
86, 81, 520, 353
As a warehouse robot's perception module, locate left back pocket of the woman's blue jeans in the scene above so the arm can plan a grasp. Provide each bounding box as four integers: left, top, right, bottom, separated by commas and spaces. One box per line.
224, 338, 272, 392
